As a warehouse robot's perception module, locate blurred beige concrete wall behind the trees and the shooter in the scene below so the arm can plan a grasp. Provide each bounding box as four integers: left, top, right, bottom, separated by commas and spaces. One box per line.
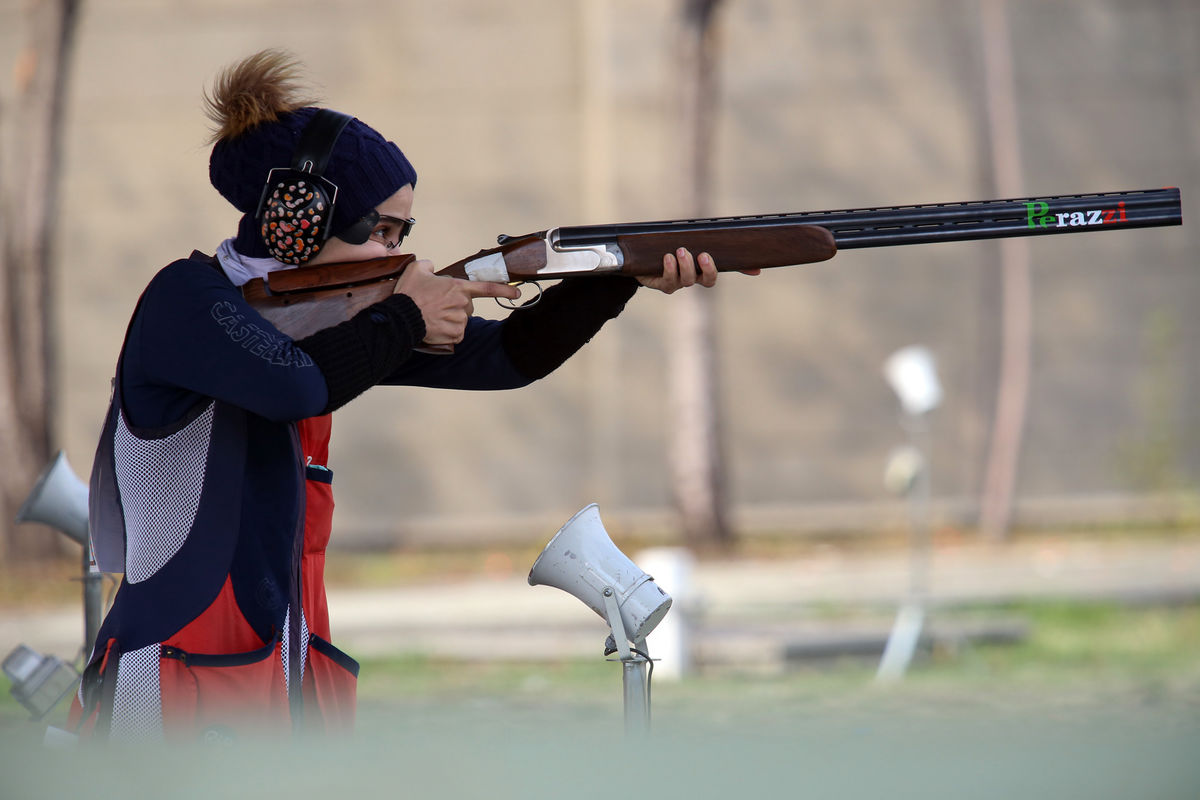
0, 0, 1200, 541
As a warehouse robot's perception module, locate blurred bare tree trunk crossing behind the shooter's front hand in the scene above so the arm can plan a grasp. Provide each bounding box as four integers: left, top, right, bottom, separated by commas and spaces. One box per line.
670, 0, 732, 551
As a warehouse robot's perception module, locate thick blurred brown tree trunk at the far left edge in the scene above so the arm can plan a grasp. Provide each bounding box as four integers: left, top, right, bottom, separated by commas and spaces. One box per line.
0, 0, 79, 564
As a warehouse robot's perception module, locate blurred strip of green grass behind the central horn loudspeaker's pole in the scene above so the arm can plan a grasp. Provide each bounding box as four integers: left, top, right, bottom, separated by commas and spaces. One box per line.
359, 601, 1200, 718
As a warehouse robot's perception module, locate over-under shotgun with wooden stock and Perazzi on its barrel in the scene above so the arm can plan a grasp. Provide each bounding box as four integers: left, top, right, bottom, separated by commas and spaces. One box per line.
244, 187, 1182, 338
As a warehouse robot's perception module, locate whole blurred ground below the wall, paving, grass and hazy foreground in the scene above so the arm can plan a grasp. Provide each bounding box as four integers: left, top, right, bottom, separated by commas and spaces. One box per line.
0, 534, 1200, 800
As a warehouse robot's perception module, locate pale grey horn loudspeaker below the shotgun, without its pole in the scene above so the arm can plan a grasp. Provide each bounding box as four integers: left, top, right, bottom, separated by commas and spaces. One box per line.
529, 503, 671, 642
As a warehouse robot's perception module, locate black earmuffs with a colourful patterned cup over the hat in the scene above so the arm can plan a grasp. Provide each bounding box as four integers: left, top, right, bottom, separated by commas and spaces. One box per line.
257, 108, 355, 264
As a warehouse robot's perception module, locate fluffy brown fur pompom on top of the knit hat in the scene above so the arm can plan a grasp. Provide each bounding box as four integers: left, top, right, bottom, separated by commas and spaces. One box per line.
204, 49, 317, 144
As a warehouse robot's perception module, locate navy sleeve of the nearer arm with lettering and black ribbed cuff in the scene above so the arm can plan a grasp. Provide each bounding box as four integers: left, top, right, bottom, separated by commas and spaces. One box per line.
130, 261, 436, 427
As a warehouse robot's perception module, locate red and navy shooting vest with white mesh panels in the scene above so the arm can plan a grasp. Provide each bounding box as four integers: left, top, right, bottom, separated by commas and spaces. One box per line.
72, 267, 358, 742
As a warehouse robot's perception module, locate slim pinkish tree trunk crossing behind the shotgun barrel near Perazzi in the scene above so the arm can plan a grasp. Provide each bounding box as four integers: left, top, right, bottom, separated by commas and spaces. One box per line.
979, 0, 1033, 540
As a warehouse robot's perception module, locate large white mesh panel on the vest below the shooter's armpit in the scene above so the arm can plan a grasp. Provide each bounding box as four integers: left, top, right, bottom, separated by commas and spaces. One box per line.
113, 403, 215, 583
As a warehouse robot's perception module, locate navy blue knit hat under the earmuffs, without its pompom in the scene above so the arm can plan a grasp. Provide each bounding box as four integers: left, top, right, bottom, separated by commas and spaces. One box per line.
209, 107, 416, 257
